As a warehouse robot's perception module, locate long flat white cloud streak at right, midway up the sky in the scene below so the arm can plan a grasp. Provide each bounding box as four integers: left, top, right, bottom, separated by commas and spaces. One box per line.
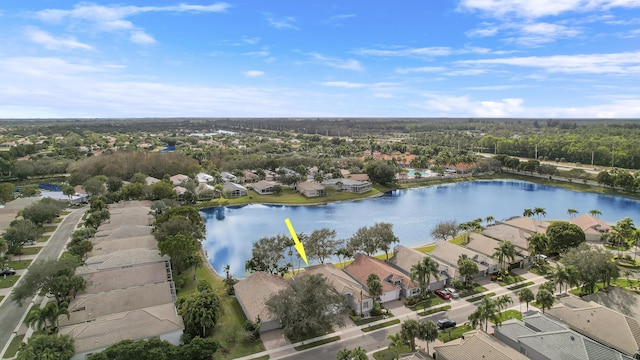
457, 51, 640, 74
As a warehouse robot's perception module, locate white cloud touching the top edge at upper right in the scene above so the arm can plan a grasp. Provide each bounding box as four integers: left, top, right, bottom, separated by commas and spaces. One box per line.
459, 0, 640, 19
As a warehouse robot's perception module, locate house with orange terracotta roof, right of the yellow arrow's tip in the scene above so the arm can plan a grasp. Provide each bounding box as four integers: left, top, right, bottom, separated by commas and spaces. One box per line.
344, 254, 420, 302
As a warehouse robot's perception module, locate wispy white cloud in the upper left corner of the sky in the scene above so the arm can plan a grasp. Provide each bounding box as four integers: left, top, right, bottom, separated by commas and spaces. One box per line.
33, 2, 230, 45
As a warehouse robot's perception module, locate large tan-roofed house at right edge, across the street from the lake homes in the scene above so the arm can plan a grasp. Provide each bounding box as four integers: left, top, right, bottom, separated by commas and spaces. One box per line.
546, 296, 640, 358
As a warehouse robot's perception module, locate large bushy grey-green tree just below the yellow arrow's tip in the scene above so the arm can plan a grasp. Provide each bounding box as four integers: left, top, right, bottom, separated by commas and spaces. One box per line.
266, 274, 348, 341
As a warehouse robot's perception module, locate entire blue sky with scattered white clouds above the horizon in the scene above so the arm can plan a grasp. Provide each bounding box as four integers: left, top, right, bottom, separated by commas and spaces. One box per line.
0, 0, 640, 118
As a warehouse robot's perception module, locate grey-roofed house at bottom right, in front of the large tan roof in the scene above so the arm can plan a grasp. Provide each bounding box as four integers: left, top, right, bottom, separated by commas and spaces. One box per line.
494, 312, 633, 360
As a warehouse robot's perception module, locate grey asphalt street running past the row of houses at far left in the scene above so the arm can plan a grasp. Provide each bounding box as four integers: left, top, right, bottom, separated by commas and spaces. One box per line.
0, 207, 87, 350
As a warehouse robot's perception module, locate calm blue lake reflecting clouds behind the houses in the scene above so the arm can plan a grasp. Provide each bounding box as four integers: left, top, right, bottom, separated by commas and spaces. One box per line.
202, 180, 640, 278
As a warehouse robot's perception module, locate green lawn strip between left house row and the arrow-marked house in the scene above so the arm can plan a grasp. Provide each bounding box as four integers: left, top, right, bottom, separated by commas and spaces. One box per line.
178, 256, 265, 359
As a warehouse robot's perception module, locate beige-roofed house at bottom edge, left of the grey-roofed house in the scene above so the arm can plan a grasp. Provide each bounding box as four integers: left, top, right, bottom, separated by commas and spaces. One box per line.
433, 330, 528, 360
